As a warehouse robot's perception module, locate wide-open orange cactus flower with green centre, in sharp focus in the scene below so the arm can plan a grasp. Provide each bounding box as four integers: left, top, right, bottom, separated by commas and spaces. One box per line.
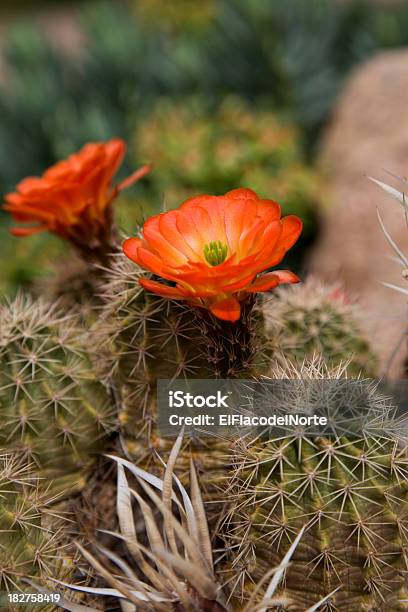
123, 189, 302, 321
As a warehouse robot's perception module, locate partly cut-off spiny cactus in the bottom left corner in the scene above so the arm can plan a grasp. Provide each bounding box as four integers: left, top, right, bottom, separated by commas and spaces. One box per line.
0, 454, 75, 612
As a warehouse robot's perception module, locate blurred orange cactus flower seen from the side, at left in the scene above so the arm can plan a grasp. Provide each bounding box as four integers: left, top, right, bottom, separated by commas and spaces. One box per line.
3, 139, 150, 256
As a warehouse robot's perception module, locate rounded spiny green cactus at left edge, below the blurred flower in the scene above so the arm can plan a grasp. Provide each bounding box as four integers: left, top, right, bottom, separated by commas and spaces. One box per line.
0, 297, 113, 491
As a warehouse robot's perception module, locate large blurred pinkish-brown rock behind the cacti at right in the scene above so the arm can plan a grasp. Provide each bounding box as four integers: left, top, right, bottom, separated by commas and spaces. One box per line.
309, 51, 408, 376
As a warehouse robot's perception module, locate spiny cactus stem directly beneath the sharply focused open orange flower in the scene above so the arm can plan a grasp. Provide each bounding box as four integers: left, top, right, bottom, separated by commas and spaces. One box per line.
99, 258, 262, 480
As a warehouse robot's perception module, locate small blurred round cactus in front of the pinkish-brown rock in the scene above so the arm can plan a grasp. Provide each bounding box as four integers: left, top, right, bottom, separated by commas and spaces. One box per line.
263, 277, 377, 376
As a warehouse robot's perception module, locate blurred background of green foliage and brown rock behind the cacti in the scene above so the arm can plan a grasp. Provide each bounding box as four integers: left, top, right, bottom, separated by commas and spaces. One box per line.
0, 0, 408, 376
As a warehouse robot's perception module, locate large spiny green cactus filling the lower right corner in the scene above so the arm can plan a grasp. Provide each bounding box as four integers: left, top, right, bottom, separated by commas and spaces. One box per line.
221, 361, 408, 612
